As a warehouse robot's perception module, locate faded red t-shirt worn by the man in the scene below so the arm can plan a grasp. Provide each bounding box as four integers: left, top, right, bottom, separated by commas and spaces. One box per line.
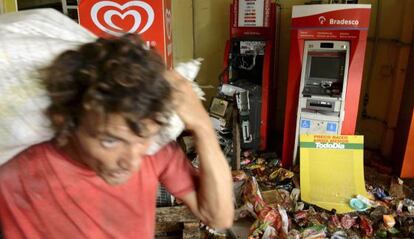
0, 142, 196, 239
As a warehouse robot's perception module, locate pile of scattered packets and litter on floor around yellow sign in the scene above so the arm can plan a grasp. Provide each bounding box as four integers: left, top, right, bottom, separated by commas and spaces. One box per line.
233, 152, 414, 239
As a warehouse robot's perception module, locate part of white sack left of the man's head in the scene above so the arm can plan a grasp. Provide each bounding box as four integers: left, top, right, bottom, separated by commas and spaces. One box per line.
0, 9, 96, 164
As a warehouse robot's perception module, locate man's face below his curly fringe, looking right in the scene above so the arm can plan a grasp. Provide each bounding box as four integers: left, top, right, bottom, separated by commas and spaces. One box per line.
69, 112, 160, 185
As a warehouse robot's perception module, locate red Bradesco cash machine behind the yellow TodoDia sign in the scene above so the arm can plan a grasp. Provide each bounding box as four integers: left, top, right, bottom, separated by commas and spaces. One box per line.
282, 4, 371, 167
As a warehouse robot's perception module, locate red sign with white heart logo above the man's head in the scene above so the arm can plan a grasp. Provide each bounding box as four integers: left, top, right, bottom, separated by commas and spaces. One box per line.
79, 0, 172, 68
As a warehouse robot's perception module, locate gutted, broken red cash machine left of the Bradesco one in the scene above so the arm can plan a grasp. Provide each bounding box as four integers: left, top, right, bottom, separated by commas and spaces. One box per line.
221, 0, 280, 150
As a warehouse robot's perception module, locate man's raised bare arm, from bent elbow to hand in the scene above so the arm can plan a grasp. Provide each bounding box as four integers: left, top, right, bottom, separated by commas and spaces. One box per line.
166, 71, 234, 228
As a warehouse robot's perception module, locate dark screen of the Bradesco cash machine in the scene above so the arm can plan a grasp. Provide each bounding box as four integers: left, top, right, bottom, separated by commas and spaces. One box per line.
309, 56, 345, 80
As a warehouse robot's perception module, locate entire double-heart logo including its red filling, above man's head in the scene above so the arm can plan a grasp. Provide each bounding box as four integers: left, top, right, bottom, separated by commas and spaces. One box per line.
91, 0, 155, 36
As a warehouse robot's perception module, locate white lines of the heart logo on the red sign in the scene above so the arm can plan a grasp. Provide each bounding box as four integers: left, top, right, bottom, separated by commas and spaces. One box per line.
91, 1, 155, 36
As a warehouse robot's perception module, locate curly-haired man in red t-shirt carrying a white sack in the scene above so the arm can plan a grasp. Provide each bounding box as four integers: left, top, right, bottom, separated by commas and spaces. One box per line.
0, 35, 233, 238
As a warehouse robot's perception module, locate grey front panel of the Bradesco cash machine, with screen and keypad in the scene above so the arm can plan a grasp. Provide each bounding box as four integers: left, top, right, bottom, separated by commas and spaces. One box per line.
294, 40, 349, 160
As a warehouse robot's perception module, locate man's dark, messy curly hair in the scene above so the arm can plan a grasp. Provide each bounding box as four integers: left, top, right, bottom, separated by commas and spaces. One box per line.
41, 34, 171, 142
